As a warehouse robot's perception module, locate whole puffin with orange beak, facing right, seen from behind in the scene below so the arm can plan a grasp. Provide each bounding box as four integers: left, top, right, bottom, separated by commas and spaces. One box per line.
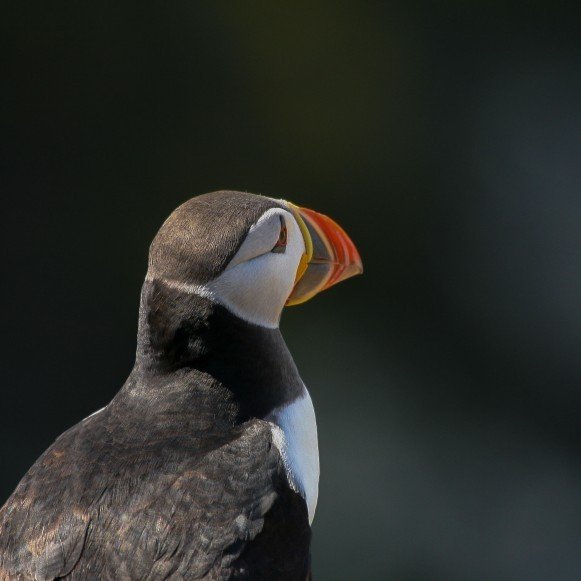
0, 191, 363, 581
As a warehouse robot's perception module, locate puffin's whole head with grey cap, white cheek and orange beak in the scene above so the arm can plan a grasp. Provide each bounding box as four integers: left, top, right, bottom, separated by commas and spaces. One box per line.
147, 191, 363, 328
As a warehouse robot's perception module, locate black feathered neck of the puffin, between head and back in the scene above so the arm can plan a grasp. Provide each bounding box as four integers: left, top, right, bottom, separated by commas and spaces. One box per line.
123, 280, 304, 423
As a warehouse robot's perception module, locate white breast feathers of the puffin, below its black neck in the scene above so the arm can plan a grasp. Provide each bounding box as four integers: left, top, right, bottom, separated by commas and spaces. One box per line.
264, 387, 319, 523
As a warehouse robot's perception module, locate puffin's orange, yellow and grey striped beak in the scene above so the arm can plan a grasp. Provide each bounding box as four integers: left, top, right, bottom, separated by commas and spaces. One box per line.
286, 202, 363, 305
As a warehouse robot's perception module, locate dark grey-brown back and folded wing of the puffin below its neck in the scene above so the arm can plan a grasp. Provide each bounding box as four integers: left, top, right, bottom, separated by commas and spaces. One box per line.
0, 412, 310, 580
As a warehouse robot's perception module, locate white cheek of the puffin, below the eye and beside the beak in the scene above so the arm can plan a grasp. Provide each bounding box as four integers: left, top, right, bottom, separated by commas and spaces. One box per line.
205, 212, 304, 328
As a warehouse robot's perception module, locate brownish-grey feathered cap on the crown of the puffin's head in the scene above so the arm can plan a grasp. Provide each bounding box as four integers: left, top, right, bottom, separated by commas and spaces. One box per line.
148, 190, 284, 284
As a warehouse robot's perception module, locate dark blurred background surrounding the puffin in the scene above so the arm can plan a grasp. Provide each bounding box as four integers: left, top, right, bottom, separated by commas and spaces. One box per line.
0, 0, 581, 581
